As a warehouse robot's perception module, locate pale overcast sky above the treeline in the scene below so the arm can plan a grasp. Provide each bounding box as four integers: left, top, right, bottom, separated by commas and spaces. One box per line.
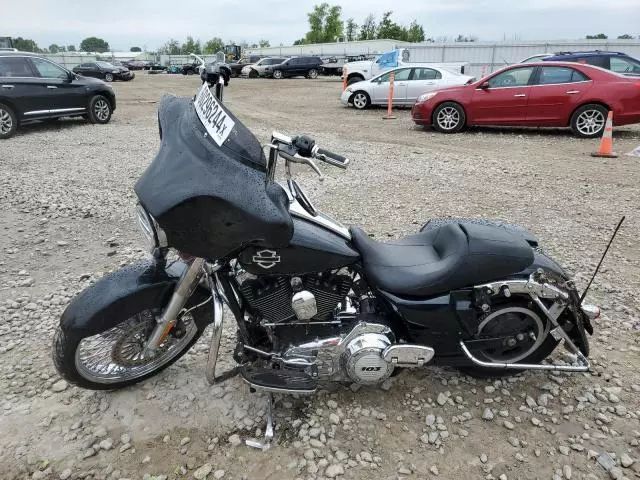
0, 0, 640, 50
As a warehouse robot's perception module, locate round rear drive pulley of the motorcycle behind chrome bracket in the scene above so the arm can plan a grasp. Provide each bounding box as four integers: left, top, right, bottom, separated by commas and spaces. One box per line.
478, 307, 548, 363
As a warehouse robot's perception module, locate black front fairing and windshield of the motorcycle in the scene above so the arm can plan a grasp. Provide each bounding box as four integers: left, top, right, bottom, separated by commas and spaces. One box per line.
135, 96, 293, 259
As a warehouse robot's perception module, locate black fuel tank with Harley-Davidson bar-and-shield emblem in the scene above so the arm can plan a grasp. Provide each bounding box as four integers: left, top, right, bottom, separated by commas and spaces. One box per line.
238, 217, 360, 275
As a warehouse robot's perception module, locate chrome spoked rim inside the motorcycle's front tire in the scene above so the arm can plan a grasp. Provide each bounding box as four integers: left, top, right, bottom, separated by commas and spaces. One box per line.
75, 310, 198, 384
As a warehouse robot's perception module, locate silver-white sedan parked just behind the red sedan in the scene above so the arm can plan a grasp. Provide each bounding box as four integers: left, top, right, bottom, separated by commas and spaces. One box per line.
340, 67, 475, 110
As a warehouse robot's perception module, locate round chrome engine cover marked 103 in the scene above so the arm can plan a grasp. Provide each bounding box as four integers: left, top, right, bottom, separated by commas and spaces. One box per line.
342, 333, 393, 384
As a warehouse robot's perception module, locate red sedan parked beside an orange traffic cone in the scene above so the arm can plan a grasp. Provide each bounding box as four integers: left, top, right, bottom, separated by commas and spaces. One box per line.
411, 62, 640, 138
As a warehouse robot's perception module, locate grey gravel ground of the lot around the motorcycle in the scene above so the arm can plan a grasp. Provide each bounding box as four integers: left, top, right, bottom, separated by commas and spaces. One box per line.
0, 75, 640, 480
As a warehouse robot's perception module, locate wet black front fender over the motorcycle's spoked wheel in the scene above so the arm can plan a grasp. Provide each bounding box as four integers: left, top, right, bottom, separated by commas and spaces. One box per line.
60, 260, 211, 337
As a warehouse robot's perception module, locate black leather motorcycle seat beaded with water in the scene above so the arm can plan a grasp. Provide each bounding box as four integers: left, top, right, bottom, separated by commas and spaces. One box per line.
351, 223, 533, 297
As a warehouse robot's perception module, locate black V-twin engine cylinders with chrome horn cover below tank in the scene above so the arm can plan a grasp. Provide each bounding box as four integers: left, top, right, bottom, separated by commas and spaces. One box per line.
236, 272, 353, 323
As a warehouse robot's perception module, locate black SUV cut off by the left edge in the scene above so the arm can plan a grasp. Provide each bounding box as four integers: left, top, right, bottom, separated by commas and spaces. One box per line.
0, 52, 116, 139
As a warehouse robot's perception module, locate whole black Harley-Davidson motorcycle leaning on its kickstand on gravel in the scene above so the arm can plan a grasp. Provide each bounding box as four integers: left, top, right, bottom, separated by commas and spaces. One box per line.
53, 68, 599, 446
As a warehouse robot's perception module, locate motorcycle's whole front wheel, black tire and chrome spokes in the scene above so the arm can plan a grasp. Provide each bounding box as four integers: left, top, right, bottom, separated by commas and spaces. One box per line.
53, 302, 207, 390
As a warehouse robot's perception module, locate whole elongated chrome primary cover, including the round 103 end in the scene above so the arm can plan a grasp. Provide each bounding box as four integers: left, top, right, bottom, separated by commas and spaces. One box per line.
282, 322, 395, 384
